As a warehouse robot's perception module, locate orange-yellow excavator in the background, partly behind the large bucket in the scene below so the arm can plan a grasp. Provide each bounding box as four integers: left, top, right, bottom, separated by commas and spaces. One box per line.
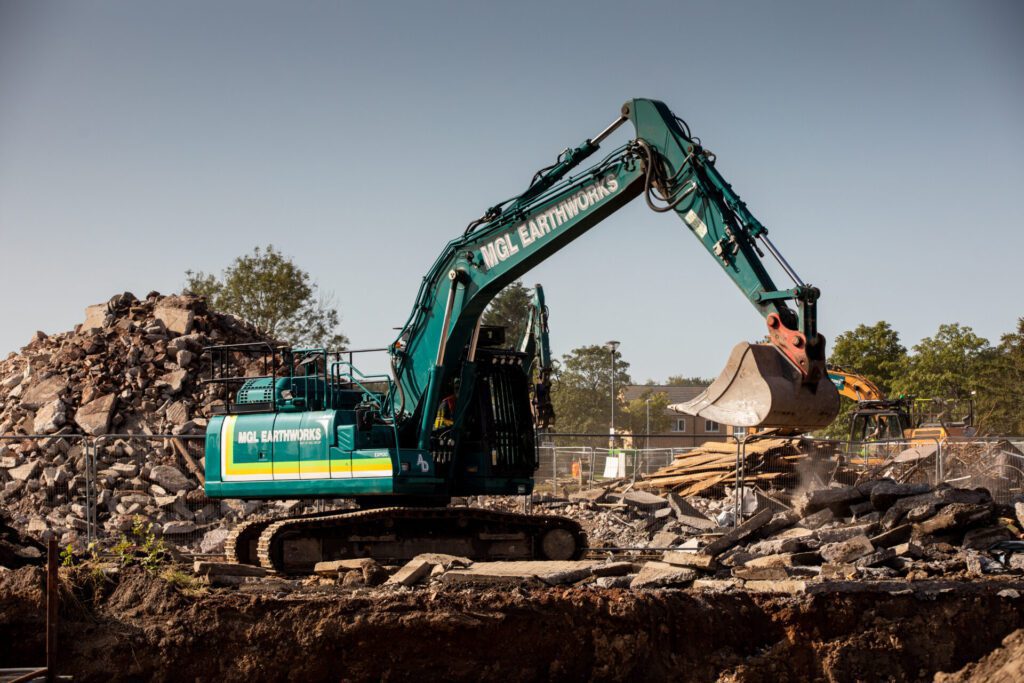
827, 366, 975, 445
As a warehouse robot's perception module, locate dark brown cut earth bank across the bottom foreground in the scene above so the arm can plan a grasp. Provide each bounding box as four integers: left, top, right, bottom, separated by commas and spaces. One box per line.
0, 567, 1024, 682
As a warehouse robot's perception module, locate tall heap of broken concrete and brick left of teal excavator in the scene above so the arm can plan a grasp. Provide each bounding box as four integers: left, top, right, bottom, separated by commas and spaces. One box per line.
0, 292, 284, 545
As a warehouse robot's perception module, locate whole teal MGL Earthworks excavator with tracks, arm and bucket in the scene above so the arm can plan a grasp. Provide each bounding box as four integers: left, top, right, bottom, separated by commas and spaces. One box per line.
206, 99, 839, 573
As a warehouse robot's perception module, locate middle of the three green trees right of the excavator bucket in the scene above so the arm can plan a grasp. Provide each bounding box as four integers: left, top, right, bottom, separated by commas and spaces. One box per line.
893, 323, 992, 399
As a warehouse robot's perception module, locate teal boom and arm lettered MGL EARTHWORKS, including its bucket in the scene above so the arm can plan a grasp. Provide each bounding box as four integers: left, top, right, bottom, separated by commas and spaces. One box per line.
390, 99, 839, 449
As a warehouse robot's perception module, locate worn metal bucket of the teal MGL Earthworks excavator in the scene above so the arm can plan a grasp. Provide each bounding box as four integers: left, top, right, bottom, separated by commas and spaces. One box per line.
669, 342, 839, 430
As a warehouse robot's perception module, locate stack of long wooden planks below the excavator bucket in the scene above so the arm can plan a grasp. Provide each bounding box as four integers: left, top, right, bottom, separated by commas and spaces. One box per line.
636, 438, 807, 497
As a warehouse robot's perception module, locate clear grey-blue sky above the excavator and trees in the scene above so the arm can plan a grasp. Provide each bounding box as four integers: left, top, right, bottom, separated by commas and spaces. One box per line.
0, 0, 1024, 381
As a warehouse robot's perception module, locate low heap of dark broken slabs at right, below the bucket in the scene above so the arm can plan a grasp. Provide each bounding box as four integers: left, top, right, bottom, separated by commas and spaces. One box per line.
637, 479, 1024, 590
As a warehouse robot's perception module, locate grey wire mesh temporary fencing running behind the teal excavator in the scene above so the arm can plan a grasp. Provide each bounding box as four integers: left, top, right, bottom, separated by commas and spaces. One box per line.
0, 434, 1024, 552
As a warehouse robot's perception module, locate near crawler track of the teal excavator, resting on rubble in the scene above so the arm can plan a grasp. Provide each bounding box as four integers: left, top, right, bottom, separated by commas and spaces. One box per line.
256, 507, 587, 574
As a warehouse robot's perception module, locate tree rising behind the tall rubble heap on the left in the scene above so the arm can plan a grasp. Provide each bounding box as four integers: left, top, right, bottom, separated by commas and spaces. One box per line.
185, 245, 348, 350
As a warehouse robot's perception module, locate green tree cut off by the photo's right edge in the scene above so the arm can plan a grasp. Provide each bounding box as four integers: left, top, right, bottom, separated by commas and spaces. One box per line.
976, 317, 1024, 435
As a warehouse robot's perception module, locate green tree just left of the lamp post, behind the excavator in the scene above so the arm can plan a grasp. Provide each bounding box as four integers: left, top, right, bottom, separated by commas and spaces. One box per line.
551, 345, 632, 434
